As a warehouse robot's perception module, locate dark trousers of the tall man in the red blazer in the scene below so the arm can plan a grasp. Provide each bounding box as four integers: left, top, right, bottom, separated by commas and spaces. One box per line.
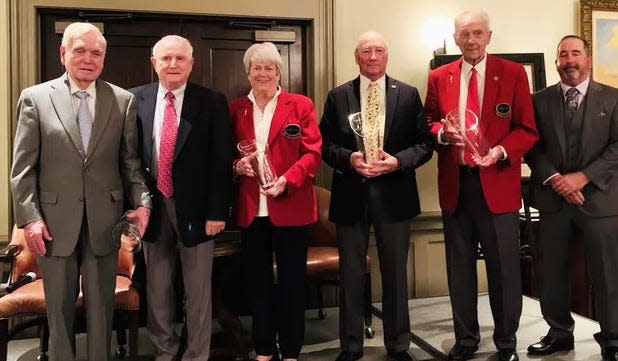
442, 168, 522, 349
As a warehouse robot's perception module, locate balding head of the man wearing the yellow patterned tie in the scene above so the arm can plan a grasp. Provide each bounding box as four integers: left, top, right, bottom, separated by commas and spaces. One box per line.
354, 30, 388, 81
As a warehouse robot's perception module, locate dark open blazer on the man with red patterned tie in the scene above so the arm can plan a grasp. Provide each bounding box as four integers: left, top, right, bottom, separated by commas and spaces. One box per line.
131, 83, 232, 246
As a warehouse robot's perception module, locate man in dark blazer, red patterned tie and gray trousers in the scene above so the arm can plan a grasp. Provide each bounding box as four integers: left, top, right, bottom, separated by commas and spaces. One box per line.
132, 35, 232, 361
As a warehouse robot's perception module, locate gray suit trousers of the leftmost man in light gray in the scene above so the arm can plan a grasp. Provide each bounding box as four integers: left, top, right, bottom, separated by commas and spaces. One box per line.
37, 217, 118, 361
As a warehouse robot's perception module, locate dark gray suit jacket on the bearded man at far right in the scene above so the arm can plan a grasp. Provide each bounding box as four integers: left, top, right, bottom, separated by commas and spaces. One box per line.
526, 81, 618, 217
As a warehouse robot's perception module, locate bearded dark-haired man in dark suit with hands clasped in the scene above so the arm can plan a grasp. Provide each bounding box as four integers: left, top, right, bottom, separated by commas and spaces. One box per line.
526, 35, 618, 360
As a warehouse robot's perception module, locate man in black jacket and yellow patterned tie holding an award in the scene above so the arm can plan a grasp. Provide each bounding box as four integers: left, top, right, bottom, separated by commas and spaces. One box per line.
320, 31, 433, 361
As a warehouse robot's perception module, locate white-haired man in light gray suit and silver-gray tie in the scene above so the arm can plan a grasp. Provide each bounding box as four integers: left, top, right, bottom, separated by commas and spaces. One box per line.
11, 23, 151, 361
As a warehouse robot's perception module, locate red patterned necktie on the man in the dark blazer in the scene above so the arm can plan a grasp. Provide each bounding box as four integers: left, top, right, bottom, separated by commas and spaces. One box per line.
157, 91, 178, 197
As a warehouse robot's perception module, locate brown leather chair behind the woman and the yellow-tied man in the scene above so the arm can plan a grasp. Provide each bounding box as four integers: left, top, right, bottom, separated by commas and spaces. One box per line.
307, 186, 375, 338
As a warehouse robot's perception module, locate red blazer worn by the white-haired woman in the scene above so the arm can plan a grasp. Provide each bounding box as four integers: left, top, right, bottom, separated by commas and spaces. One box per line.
229, 91, 322, 227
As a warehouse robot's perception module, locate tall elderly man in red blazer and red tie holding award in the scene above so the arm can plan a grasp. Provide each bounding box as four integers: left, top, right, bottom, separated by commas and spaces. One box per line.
425, 12, 537, 361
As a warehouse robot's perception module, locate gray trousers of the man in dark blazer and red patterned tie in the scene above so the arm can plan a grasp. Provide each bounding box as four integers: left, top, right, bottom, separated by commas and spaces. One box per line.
144, 198, 214, 361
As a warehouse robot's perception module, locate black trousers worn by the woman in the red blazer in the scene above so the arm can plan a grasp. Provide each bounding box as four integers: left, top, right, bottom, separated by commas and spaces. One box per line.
241, 217, 308, 358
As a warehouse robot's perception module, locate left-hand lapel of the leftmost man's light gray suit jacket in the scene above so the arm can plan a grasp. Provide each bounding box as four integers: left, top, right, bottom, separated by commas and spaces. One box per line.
50, 73, 86, 158
